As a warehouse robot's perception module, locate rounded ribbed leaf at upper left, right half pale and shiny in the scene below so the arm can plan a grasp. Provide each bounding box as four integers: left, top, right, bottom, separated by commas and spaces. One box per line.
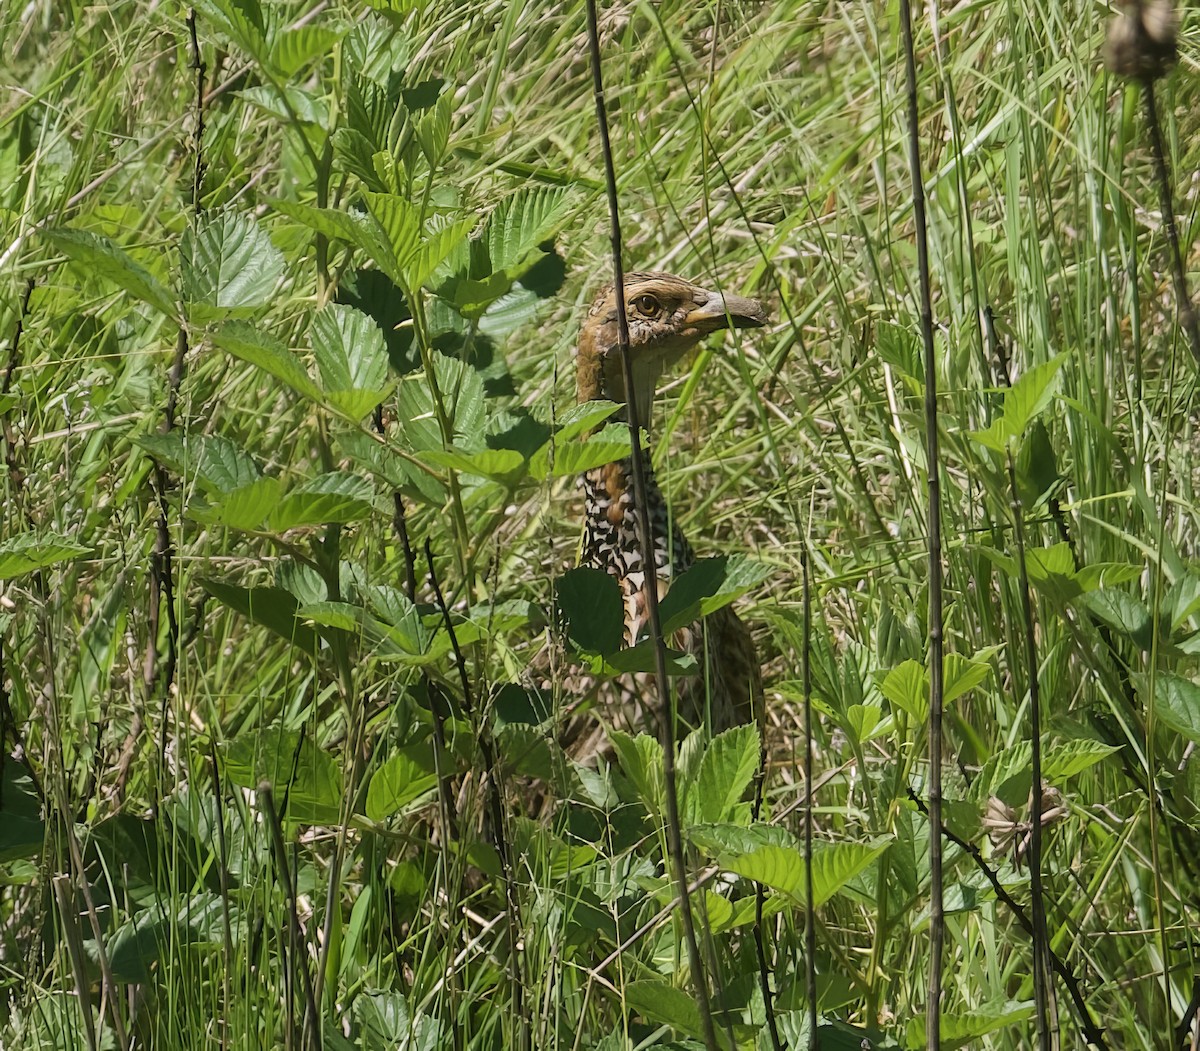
180, 212, 284, 318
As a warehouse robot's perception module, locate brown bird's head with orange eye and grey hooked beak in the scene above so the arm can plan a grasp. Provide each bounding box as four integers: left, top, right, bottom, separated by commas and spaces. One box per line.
576, 272, 767, 426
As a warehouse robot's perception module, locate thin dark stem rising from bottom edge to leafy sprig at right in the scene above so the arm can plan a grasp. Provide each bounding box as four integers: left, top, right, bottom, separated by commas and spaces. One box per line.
1008, 452, 1054, 1051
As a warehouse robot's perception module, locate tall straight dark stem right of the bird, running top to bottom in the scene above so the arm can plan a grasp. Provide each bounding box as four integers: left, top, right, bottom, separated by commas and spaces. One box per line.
900, 0, 946, 1051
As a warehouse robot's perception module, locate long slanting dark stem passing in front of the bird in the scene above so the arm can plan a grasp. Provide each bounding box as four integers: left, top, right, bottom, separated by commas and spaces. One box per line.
587, 0, 719, 1051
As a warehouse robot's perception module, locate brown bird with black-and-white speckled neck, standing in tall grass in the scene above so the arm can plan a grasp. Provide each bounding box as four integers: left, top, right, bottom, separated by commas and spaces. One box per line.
576, 272, 768, 748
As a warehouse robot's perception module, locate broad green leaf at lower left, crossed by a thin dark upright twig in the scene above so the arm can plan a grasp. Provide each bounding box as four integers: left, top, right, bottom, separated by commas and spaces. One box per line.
222, 723, 342, 824
